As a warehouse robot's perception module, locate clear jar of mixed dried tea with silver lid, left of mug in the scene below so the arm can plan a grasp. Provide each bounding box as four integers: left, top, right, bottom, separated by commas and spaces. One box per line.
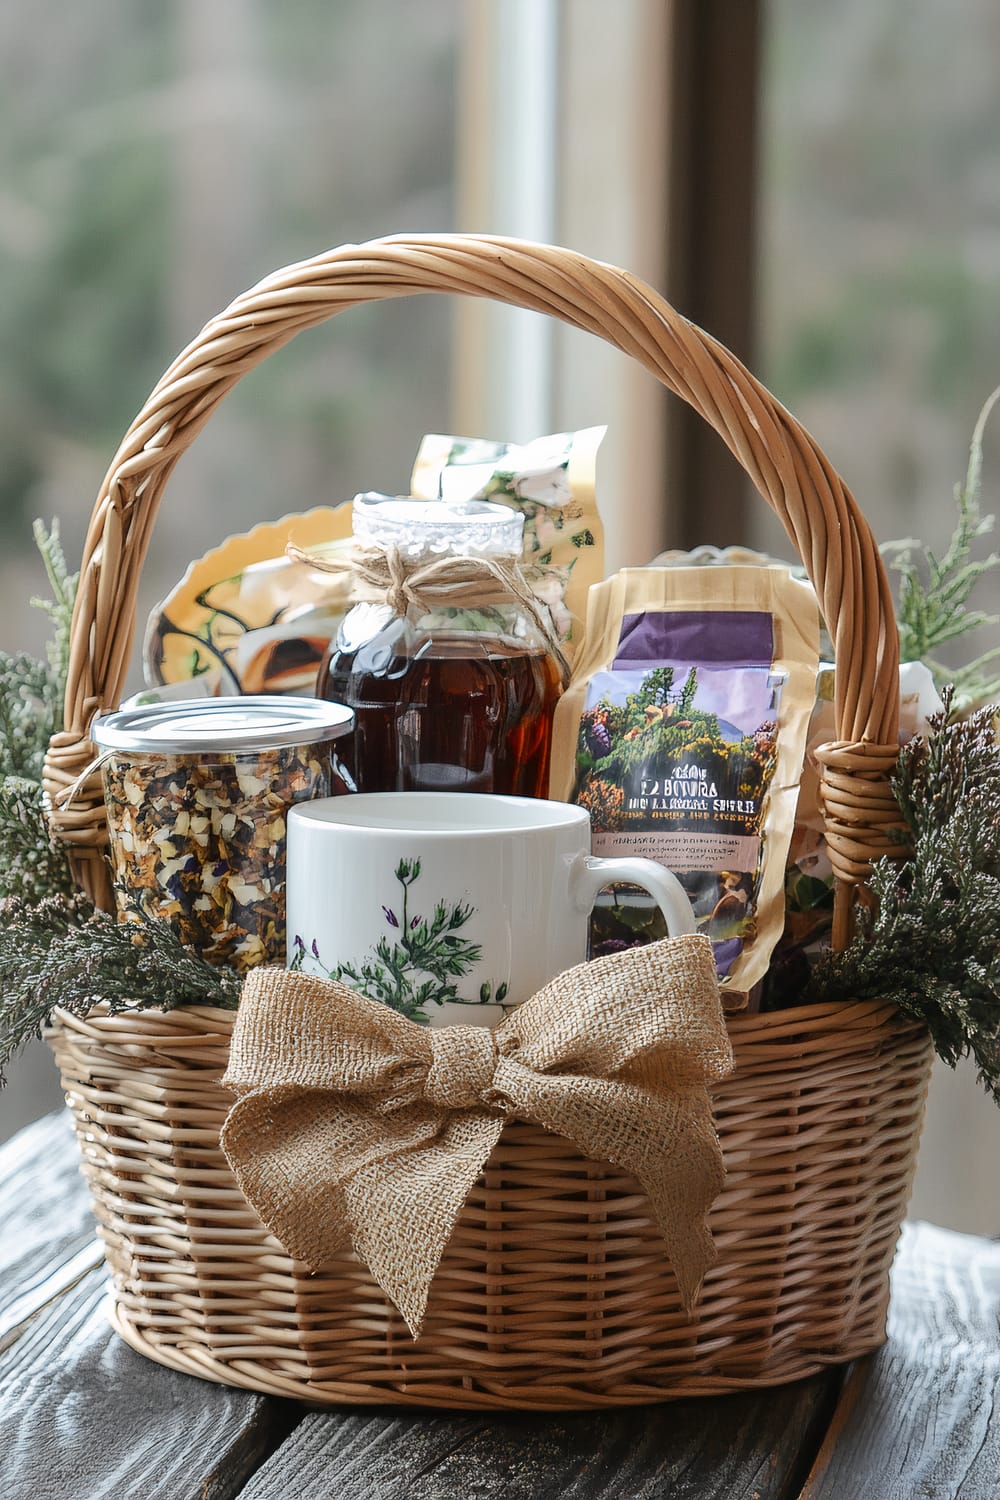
91, 696, 354, 969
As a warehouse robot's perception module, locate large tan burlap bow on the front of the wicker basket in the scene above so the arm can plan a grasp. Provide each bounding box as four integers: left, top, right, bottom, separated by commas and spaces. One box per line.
222, 936, 732, 1338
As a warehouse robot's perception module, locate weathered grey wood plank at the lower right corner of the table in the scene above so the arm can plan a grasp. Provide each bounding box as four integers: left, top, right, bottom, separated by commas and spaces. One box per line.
802, 1224, 1000, 1500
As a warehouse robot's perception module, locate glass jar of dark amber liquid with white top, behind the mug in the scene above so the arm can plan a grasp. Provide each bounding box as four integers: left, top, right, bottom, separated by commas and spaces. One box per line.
316, 495, 562, 797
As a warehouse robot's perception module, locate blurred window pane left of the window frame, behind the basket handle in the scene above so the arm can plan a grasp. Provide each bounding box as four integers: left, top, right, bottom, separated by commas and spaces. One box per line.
0, 0, 462, 663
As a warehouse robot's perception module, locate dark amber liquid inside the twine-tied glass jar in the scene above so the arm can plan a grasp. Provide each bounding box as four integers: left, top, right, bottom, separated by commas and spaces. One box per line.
316, 627, 562, 797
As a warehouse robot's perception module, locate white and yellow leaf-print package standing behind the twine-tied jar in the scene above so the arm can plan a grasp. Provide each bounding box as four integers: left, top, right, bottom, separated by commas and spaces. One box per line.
409, 428, 607, 660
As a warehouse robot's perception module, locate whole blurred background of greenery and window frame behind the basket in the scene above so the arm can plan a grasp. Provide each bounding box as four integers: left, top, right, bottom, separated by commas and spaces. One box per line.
0, 0, 1000, 1233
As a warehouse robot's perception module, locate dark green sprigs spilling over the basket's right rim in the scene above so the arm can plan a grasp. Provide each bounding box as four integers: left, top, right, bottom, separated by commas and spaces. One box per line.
802, 689, 1000, 1103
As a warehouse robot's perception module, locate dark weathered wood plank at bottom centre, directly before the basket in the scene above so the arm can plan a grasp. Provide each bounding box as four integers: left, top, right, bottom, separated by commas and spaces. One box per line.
240, 1374, 840, 1500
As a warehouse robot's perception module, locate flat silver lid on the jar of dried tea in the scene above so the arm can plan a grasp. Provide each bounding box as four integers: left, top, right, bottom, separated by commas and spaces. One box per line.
90, 695, 354, 755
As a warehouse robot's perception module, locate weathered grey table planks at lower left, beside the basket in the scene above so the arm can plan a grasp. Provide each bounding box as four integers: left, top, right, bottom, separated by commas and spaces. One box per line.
0, 1119, 301, 1500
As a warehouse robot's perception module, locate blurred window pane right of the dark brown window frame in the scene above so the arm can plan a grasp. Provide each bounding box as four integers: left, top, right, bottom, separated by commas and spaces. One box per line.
760, 0, 1000, 564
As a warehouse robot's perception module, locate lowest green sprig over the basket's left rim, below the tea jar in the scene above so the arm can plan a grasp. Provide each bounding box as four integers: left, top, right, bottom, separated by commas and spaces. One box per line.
0, 896, 241, 1083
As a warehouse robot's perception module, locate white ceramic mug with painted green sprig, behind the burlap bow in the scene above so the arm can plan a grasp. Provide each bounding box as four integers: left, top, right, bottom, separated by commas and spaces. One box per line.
286, 792, 694, 1026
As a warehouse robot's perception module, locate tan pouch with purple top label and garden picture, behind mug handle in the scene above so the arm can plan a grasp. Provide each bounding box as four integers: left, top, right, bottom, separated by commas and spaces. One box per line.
549, 567, 819, 1004
